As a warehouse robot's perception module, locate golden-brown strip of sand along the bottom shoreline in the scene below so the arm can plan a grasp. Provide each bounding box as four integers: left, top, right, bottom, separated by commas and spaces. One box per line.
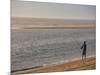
12, 57, 96, 74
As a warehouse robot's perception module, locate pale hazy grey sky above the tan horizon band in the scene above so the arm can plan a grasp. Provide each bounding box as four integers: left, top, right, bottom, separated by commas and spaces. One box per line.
11, 0, 96, 19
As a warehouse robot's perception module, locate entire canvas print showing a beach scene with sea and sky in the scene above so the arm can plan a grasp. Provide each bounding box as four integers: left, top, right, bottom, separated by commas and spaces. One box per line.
10, 0, 96, 75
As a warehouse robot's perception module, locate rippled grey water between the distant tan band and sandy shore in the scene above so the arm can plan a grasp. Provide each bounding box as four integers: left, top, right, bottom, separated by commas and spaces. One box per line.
11, 28, 96, 71
